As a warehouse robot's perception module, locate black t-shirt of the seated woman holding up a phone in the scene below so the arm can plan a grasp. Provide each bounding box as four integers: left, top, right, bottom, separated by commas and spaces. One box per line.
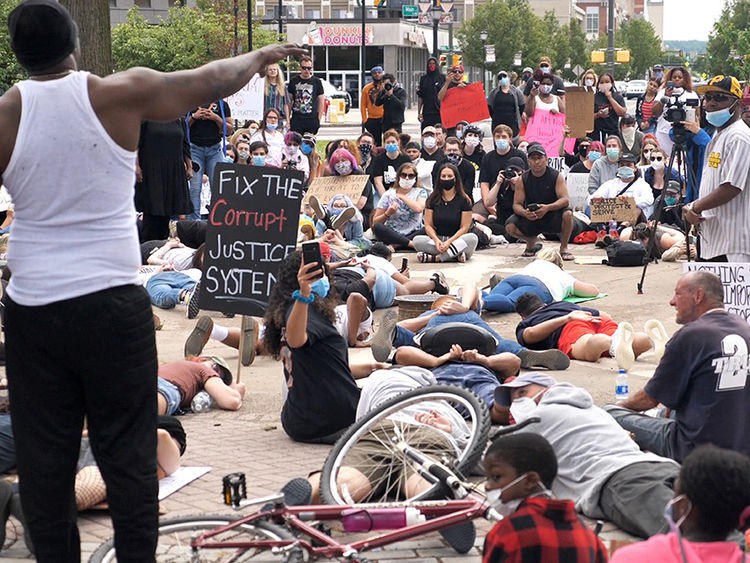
281, 305, 359, 441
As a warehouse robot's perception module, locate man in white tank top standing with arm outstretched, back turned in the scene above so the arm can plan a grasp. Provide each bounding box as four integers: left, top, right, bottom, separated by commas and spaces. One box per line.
0, 0, 304, 563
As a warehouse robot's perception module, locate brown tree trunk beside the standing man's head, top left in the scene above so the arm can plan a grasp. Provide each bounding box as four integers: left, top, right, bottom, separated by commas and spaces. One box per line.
61, 0, 112, 76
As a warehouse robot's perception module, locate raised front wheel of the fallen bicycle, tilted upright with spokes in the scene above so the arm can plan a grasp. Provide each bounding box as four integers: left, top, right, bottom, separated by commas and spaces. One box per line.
320, 385, 490, 504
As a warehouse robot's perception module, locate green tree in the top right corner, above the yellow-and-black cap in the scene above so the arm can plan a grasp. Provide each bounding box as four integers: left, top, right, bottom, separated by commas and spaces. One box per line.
706, 0, 750, 80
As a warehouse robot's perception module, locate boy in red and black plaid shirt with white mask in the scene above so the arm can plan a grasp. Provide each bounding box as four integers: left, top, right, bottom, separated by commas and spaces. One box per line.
483, 432, 607, 563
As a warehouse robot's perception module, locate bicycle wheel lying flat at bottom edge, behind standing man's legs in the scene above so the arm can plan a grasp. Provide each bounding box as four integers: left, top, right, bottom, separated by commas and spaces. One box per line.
89, 515, 304, 563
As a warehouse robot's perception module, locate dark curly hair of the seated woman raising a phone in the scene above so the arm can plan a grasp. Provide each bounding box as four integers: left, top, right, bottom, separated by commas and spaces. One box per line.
263, 251, 340, 360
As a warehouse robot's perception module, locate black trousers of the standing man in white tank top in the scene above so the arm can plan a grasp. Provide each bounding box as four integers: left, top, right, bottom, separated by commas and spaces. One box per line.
4, 286, 158, 563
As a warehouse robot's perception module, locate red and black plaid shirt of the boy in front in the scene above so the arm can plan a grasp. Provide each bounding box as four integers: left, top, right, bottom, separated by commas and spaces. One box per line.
483, 497, 607, 563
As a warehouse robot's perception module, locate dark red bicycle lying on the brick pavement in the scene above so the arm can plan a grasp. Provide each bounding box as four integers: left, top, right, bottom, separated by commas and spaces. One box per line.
89, 386, 539, 563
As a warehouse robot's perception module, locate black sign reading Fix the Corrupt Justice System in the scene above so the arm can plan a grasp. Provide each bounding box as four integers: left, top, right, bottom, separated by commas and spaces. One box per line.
199, 163, 305, 317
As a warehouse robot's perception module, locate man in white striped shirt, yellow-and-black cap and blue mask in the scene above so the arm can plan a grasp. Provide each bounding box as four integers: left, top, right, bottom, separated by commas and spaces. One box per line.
683, 75, 750, 262
